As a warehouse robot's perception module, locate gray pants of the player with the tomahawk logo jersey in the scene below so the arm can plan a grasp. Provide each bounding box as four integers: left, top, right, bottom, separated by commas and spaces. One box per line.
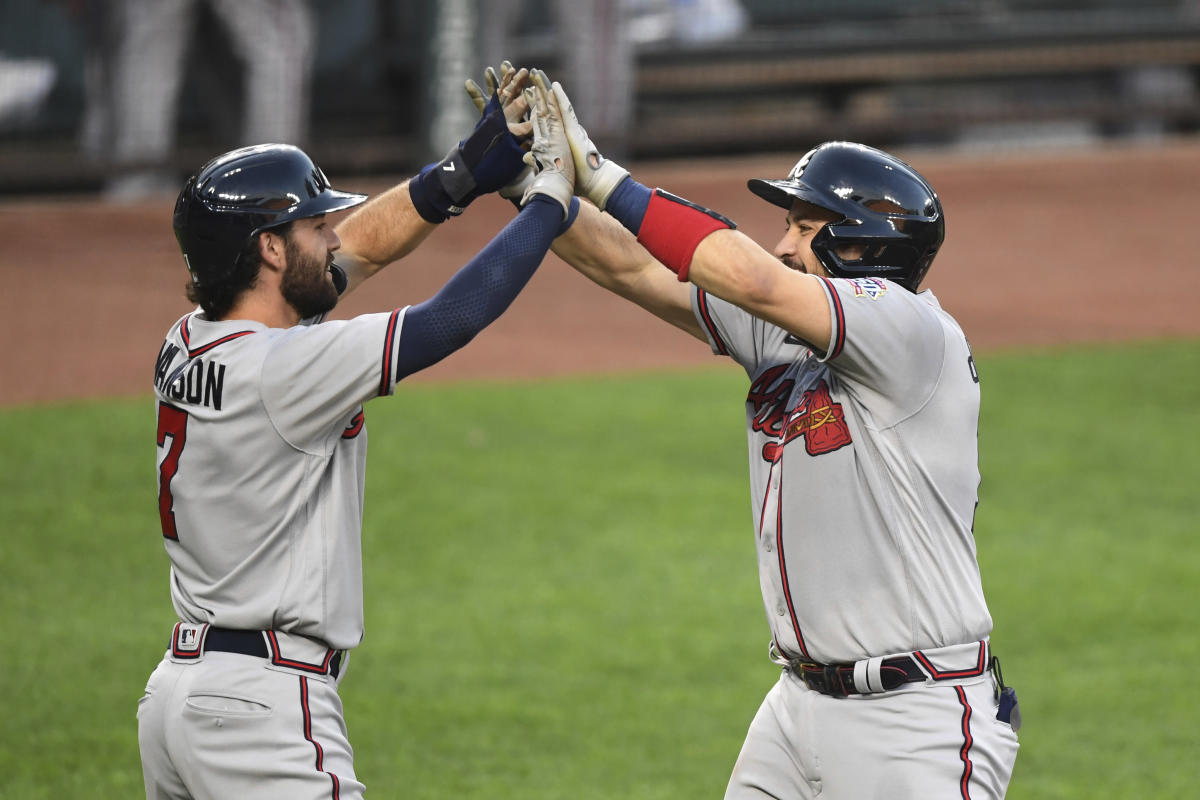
725, 673, 1018, 800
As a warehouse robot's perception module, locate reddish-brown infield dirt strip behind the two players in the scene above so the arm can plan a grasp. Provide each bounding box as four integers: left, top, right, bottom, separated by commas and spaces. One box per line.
0, 142, 1200, 405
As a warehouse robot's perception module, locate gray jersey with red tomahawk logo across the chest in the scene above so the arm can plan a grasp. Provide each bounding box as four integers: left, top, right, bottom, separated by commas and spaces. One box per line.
692, 278, 991, 663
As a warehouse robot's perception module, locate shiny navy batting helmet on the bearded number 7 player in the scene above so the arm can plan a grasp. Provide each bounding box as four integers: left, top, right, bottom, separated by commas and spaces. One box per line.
174, 144, 367, 285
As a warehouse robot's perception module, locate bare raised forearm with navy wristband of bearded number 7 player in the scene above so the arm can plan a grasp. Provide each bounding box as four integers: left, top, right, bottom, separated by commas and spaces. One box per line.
336, 65, 530, 294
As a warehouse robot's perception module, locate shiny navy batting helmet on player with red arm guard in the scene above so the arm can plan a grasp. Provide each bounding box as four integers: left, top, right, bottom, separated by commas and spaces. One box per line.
748, 142, 946, 291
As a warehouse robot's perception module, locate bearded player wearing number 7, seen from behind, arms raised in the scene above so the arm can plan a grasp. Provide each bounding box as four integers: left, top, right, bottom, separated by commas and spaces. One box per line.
138, 73, 578, 800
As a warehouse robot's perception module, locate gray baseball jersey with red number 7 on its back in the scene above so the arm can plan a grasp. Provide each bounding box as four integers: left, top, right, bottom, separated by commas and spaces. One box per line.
148, 309, 406, 650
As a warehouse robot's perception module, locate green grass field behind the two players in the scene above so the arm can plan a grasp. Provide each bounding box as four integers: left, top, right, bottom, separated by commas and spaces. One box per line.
0, 342, 1200, 800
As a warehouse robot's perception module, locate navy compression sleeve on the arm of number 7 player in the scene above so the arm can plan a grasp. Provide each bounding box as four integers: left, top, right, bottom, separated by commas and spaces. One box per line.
396, 194, 563, 380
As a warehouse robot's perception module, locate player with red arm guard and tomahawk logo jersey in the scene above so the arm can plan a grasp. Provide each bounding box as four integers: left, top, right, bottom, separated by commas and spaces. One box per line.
516, 73, 1019, 800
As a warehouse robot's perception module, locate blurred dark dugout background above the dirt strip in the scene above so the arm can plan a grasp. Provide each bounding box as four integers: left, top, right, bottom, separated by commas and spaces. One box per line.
0, 0, 1200, 201
